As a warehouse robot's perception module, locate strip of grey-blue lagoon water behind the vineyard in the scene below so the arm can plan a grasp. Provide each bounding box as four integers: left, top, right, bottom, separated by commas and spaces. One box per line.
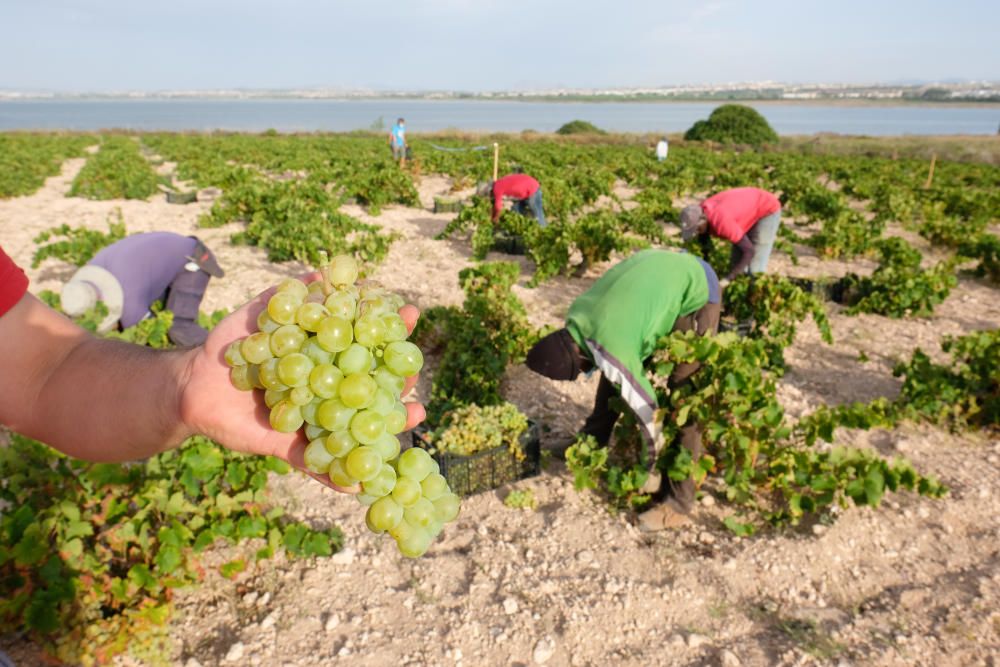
0, 99, 1000, 135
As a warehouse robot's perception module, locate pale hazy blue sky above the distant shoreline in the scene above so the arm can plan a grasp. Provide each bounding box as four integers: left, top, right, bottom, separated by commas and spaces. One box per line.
0, 0, 1000, 92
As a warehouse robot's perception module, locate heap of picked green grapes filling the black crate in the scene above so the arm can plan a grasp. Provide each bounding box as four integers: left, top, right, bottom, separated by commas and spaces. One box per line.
434, 403, 528, 460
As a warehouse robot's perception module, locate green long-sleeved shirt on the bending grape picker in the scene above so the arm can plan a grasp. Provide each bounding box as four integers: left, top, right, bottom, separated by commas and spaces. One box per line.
566, 249, 720, 460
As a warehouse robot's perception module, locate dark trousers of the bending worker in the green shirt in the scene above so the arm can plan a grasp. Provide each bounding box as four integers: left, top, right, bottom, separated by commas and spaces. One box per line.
582, 303, 722, 510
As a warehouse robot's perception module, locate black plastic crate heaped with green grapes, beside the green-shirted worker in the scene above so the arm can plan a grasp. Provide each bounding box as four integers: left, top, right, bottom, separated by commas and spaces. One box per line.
413, 421, 541, 497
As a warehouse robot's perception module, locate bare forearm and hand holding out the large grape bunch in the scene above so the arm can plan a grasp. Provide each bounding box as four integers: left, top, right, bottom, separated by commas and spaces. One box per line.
0, 288, 424, 486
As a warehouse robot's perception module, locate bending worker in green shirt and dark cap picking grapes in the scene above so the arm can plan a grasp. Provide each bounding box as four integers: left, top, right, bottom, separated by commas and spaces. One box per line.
527, 249, 721, 530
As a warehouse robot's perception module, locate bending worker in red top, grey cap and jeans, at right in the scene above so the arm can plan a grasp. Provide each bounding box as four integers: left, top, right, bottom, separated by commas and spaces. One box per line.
680, 188, 781, 283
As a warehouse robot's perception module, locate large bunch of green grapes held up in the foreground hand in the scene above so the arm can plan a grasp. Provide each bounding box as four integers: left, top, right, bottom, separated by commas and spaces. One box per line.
225, 255, 459, 558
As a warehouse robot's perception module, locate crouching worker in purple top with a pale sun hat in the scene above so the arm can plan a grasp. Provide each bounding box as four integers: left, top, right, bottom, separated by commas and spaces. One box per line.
61, 232, 223, 346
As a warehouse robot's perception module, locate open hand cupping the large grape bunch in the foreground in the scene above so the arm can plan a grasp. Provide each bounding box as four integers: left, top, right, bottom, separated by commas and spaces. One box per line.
180, 273, 426, 493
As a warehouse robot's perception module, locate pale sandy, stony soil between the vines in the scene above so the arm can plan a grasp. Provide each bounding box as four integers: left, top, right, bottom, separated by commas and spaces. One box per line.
0, 160, 1000, 667
